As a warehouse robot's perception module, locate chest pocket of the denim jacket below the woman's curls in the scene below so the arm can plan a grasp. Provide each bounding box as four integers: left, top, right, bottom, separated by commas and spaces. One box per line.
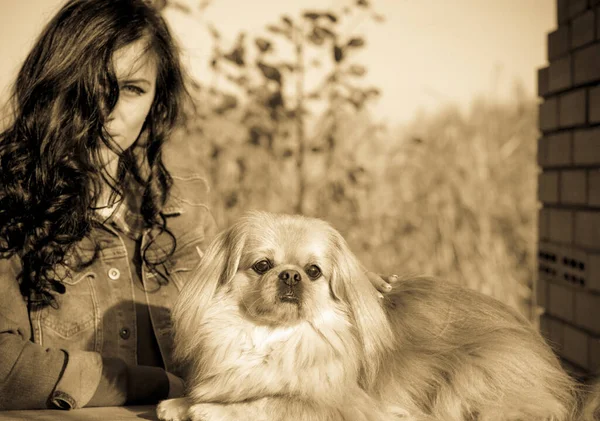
40, 271, 99, 351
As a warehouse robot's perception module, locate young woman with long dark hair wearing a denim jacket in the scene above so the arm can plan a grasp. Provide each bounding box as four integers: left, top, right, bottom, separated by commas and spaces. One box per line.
0, 0, 386, 409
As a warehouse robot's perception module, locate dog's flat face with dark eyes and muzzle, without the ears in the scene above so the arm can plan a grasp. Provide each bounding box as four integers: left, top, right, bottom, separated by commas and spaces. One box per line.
230, 218, 340, 325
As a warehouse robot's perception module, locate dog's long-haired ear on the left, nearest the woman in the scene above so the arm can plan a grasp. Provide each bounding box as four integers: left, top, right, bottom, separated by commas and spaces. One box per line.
172, 225, 245, 364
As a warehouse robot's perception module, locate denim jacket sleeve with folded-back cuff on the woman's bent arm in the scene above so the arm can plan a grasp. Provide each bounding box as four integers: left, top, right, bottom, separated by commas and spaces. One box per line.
0, 254, 102, 409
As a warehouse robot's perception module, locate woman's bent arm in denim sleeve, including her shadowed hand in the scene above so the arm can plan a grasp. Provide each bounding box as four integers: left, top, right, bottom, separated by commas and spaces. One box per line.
0, 259, 180, 409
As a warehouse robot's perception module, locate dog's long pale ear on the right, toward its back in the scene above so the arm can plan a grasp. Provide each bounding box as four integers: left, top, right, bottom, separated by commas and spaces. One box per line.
331, 230, 394, 388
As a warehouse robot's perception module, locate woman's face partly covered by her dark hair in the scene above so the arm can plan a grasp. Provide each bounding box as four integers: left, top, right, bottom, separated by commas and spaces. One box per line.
105, 39, 157, 164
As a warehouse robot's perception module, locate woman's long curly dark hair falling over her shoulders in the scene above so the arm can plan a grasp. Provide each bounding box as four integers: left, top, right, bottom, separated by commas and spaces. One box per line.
0, 0, 186, 306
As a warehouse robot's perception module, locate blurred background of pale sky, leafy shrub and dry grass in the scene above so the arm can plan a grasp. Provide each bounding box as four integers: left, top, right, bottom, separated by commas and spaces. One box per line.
0, 0, 556, 317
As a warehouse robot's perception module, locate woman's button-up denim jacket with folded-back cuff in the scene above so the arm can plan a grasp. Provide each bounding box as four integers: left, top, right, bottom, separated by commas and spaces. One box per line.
0, 176, 215, 409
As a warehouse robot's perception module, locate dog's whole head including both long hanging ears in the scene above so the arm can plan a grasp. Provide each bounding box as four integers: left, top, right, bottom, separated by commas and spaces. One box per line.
173, 212, 393, 383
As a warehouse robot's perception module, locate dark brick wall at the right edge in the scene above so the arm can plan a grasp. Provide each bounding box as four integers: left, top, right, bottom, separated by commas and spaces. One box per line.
536, 0, 600, 375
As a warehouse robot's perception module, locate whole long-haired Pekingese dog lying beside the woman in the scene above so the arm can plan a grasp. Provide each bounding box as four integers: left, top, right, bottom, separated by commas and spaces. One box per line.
157, 212, 576, 421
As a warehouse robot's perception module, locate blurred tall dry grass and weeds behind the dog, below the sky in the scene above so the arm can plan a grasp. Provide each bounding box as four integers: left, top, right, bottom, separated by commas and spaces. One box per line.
164, 85, 538, 316
